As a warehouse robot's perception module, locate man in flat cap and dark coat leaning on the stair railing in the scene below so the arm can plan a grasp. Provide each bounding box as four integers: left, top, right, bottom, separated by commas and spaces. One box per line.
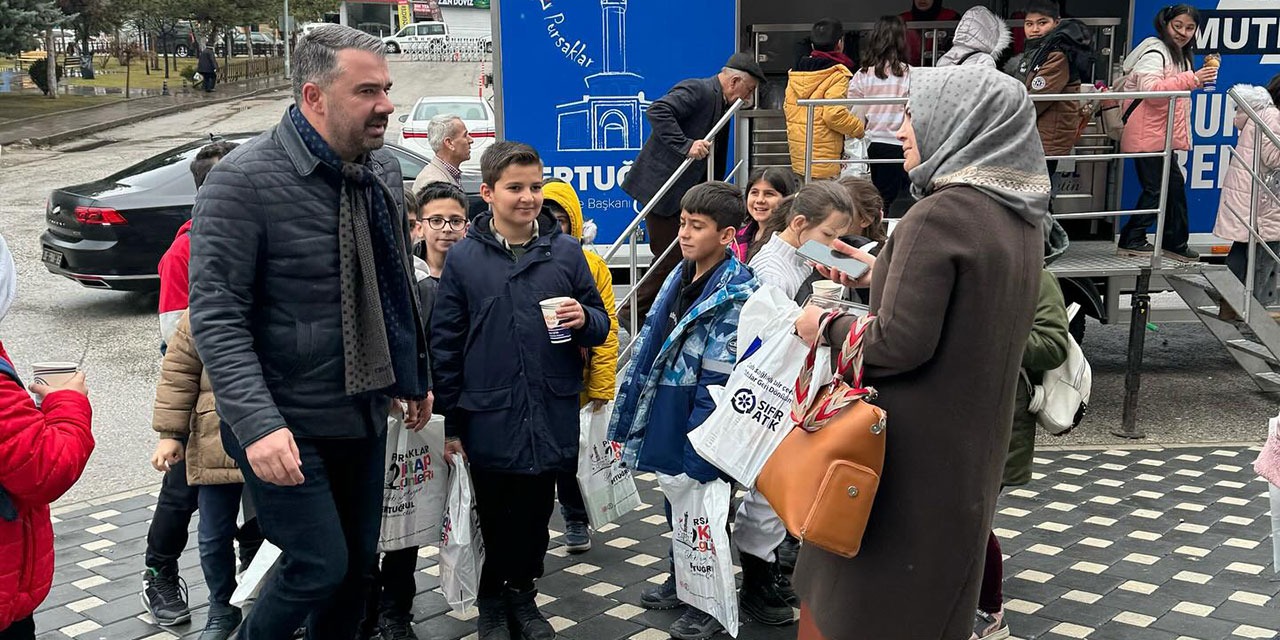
618, 51, 764, 322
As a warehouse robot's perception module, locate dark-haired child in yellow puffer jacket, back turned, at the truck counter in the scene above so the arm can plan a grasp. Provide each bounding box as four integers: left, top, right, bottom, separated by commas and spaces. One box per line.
782, 18, 865, 178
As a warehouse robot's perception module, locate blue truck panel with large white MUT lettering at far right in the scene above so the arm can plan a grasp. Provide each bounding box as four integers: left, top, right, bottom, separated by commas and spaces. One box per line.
1121, 0, 1280, 240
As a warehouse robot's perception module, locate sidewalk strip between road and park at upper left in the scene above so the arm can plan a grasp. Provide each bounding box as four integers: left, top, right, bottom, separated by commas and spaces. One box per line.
0, 77, 288, 145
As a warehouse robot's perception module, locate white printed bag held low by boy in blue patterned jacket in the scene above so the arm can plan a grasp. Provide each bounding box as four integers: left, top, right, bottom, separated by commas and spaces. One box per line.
658, 474, 737, 637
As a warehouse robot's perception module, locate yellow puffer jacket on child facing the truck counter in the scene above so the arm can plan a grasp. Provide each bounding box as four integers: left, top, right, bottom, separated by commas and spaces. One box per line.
782, 64, 865, 178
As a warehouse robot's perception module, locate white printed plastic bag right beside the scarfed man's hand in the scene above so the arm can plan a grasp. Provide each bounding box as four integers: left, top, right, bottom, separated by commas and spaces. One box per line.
378, 411, 449, 552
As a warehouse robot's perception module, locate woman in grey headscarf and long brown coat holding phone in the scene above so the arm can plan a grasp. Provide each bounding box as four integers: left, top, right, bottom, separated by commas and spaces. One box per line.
794, 65, 1050, 640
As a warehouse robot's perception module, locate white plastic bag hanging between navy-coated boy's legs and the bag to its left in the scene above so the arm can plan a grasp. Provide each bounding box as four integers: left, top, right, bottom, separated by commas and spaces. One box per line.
440, 453, 484, 613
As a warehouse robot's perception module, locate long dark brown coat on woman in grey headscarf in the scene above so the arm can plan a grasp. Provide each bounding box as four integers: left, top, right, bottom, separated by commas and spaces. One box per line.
794, 184, 1043, 640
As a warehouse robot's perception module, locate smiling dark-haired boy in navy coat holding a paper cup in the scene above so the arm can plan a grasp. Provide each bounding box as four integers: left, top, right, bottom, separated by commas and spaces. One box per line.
431, 141, 609, 640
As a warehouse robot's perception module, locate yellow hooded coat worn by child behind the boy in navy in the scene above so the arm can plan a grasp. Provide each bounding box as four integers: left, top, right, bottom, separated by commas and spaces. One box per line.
543, 182, 618, 406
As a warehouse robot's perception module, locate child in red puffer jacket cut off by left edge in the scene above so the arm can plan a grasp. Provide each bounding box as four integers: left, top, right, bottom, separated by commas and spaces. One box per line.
0, 238, 93, 640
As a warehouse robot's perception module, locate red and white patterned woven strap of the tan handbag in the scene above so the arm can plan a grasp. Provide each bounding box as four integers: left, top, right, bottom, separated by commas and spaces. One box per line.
791, 311, 876, 431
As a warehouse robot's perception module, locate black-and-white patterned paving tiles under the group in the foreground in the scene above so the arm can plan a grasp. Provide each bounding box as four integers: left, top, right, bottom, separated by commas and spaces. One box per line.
36, 445, 1280, 640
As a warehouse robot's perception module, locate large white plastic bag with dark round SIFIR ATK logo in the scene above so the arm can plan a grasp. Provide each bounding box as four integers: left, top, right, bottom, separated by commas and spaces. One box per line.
689, 333, 808, 486
